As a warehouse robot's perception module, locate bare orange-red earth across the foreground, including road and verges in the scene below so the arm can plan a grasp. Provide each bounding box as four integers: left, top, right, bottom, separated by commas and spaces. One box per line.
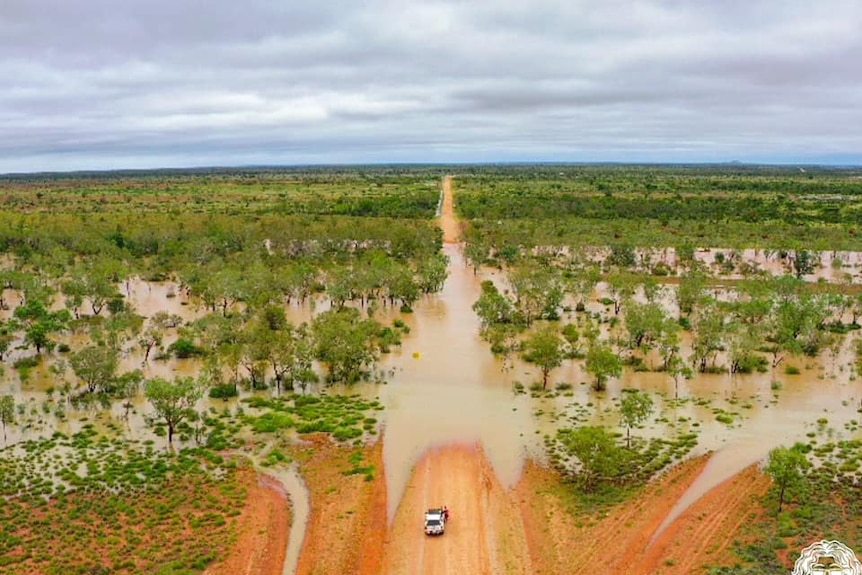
213, 448, 769, 575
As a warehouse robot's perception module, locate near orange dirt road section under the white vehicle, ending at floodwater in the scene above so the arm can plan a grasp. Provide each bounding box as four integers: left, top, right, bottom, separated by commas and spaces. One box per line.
383, 445, 530, 575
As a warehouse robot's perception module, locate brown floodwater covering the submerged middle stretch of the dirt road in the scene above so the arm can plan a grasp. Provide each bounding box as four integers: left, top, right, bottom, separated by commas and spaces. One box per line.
375, 244, 534, 518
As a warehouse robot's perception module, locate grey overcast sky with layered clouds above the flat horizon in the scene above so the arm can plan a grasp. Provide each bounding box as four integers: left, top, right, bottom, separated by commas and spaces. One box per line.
0, 0, 862, 172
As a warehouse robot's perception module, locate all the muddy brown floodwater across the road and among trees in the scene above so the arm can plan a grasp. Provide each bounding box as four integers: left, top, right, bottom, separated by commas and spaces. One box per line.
0, 244, 862, 548
